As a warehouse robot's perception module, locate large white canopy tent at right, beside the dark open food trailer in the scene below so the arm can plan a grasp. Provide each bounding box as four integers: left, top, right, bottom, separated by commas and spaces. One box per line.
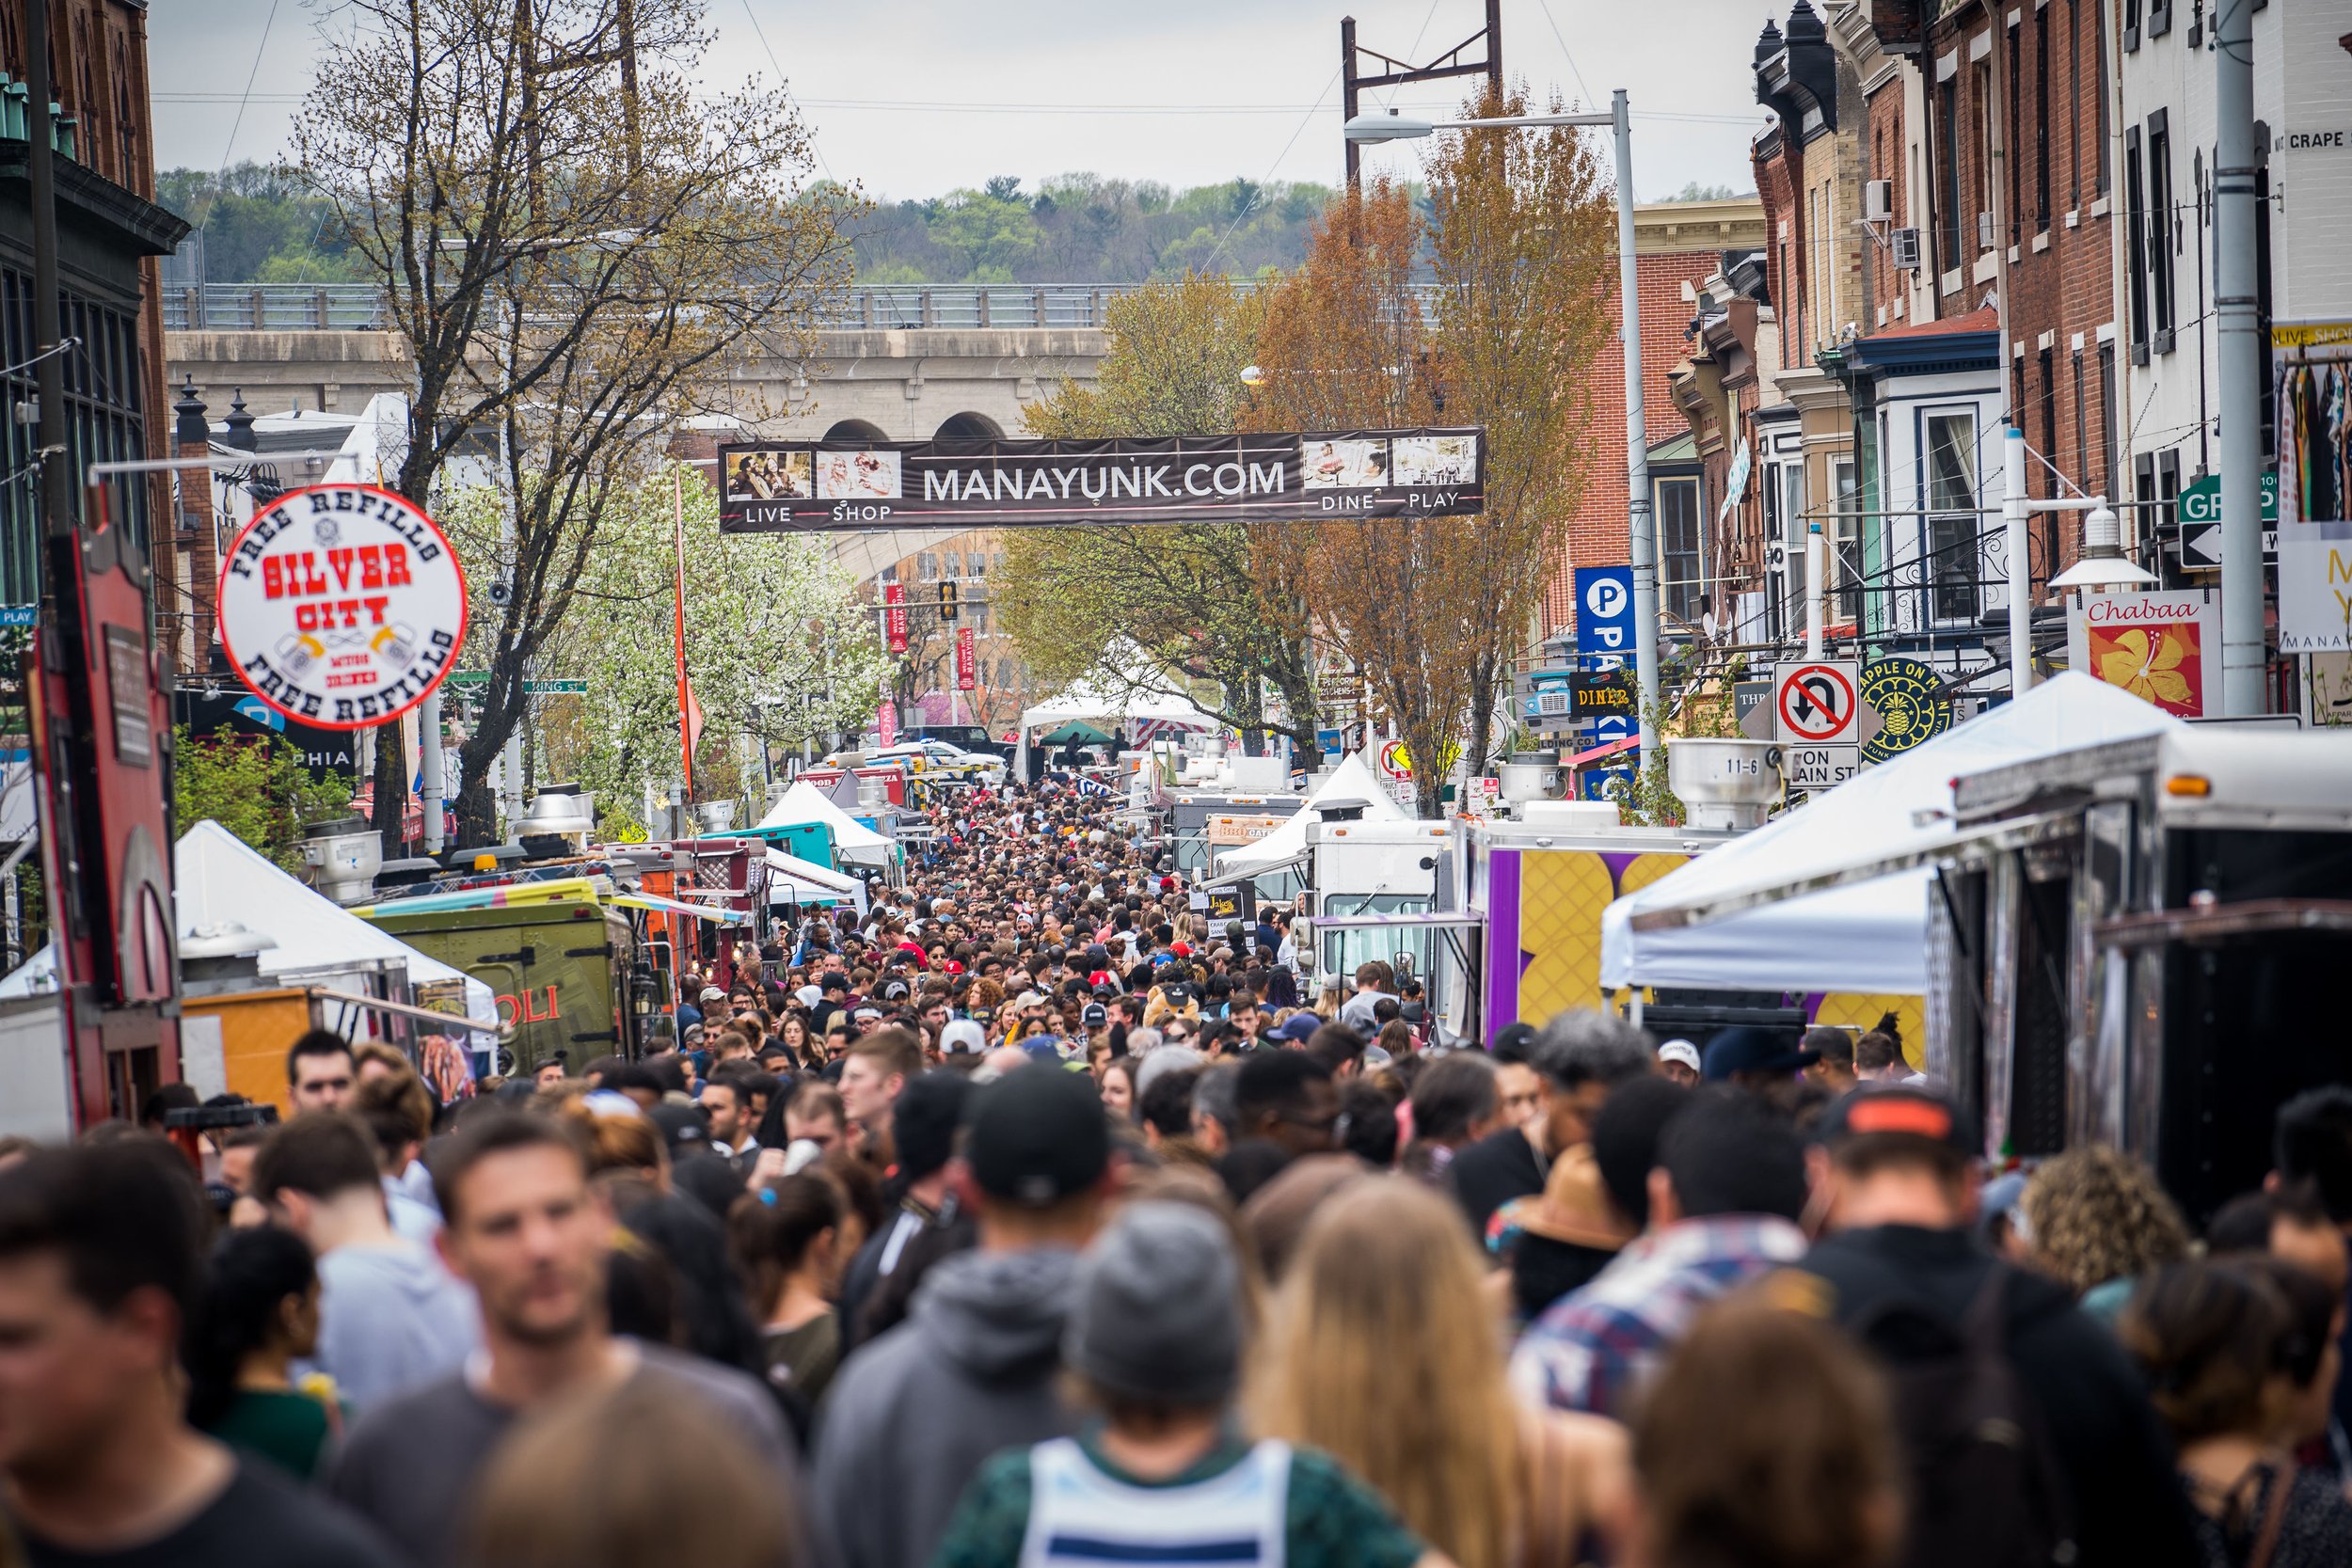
1602, 673, 2181, 994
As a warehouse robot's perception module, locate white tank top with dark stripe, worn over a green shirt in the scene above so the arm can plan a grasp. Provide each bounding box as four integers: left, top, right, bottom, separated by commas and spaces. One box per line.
1021, 1436, 1292, 1568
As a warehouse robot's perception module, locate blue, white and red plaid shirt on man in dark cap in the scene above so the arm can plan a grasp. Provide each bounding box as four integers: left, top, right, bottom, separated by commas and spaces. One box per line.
1510, 1213, 1804, 1418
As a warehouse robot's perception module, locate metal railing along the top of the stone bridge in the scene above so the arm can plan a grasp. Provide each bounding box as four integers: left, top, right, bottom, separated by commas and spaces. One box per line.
163, 279, 1428, 331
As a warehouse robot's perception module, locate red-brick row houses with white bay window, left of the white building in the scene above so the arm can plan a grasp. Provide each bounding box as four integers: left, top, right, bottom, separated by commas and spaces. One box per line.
1670, 0, 2136, 693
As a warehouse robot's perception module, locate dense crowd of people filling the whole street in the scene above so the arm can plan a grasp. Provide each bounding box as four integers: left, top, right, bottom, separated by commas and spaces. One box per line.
0, 783, 2352, 1568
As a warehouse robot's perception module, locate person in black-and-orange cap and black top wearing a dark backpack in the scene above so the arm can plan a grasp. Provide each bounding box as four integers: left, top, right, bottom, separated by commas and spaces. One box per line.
1797, 1084, 2200, 1568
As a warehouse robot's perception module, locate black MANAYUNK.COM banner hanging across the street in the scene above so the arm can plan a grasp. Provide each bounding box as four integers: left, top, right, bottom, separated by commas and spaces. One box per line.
720, 428, 1486, 533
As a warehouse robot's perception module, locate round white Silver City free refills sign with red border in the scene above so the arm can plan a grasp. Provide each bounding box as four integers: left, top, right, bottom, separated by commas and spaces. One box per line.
219, 484, 466, 729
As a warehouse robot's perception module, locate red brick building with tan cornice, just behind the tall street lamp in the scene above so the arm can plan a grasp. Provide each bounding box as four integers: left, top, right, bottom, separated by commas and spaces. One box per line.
1543, 195, 1764, 637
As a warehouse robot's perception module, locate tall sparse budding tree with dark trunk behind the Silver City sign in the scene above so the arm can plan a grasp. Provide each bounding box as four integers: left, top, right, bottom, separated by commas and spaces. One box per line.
294, 0, 861, 844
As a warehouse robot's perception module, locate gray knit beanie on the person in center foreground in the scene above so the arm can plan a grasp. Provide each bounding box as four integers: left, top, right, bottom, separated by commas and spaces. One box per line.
1061, 1201, 1242, 1406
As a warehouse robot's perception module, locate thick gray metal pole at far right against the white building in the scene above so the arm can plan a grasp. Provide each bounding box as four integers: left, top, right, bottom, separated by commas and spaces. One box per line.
2214, 0, 2270, 720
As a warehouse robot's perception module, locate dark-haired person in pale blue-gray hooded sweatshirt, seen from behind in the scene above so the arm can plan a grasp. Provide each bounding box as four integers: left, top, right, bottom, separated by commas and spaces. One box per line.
252, 1112, 483, 1413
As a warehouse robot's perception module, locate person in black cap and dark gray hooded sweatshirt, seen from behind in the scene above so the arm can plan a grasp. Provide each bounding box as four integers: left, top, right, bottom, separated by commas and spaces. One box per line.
812, 1063, 1113, 1568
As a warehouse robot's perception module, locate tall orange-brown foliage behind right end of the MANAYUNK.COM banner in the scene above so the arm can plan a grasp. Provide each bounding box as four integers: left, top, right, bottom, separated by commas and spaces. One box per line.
1251, 91, 1613, 816
